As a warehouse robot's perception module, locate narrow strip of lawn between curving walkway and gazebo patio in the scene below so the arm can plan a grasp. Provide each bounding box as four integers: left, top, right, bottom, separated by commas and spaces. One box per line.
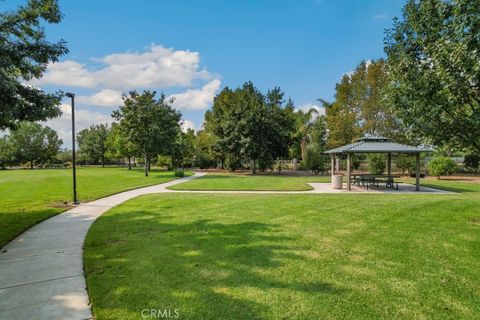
169, 174, 330, 191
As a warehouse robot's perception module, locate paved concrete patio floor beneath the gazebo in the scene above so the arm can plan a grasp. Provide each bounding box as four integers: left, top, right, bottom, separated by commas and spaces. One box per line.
309, 183, 455, 194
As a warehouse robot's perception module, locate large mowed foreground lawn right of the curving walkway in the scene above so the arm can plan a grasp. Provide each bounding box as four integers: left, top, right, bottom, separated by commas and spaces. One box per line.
84, 181, 480, 320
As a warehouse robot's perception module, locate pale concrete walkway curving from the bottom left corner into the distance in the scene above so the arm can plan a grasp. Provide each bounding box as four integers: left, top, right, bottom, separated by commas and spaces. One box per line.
0, 173, 204, 320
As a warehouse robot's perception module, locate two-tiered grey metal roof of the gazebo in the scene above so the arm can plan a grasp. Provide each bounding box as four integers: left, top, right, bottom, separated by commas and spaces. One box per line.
325, 136, 430, 153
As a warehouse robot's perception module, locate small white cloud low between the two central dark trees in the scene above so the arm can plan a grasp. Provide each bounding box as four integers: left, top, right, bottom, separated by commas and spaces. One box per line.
168, 79, 220, 110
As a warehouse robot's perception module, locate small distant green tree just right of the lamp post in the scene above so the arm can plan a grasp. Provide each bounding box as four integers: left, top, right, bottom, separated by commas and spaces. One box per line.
77, 124, 109, 167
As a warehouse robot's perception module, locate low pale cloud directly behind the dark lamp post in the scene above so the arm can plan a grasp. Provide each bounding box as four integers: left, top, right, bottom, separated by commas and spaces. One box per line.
45, 104, 112, 148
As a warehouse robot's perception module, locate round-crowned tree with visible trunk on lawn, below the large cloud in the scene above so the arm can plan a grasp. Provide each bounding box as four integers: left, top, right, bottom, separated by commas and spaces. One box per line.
112, 91, 181, 176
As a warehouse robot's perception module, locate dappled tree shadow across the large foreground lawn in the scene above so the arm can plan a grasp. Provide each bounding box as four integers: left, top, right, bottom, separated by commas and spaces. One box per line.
85, 211, 344, 319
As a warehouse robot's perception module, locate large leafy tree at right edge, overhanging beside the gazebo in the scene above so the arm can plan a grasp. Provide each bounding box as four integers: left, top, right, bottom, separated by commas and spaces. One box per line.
385, 0, 480, 152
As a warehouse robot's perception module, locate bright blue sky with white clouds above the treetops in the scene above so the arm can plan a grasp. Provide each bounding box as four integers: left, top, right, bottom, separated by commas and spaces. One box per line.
7, 0, 405, 146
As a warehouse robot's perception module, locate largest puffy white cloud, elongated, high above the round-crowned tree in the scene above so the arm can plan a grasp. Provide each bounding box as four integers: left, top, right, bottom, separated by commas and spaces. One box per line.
32, 45, 213, 91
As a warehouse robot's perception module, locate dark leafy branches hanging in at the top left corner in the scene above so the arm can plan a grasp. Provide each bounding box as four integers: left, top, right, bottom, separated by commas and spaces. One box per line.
0, 0, 68, 129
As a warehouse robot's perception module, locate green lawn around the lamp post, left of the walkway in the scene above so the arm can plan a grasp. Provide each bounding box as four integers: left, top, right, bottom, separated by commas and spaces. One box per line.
0, 167, 191, 247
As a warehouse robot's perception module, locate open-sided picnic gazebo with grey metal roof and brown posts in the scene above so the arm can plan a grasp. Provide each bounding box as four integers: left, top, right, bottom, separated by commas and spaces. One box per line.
325, 136, 429, 191
